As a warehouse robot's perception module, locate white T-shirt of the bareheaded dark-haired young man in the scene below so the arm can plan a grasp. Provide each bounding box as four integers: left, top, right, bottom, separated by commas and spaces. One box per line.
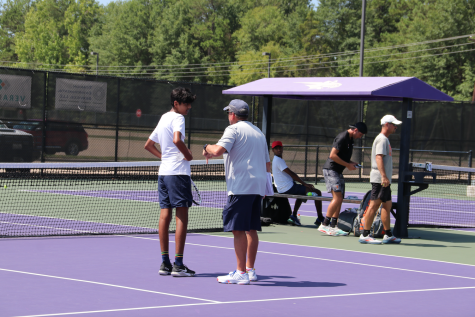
149, 112, 190, 176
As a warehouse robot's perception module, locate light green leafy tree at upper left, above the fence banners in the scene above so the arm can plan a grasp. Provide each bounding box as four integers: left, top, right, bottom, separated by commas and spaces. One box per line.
15, 0, 101, 72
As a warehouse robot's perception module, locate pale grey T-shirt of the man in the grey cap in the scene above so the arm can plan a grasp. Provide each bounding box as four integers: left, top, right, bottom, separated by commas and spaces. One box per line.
217, 121, 270, 196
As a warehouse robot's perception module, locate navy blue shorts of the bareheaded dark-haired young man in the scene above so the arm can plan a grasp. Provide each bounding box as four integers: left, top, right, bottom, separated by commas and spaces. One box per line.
158, 175, 193, 209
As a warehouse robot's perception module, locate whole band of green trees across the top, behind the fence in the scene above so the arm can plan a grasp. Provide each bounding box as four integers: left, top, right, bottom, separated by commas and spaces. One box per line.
0, 0, 475, 100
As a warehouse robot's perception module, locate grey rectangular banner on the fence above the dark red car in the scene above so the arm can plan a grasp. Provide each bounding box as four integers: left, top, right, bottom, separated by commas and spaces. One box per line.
54, 78, 107, 112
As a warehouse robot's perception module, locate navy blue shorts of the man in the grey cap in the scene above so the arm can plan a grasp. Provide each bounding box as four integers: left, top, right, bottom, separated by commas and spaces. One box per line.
223, 195, 262, 232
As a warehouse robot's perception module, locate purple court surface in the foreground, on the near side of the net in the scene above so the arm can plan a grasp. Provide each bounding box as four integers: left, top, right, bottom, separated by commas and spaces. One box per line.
0, 234, 475, 317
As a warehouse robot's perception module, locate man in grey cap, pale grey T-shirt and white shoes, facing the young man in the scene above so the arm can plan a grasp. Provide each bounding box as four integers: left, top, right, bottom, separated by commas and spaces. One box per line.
203, 99, 270, 284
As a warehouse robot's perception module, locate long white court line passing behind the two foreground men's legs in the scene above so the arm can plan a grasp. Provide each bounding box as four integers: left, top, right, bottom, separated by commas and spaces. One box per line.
116, 236, 475, 280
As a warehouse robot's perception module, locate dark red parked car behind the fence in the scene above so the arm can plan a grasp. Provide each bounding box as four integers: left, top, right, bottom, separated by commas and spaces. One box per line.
13, 121, 89, 155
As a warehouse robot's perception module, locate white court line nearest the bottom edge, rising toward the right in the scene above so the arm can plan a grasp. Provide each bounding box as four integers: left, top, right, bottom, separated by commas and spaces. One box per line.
11, 286, 475, 317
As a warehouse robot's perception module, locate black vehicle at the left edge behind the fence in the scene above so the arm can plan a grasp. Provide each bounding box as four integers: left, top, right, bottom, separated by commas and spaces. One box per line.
0, 121, 35, 162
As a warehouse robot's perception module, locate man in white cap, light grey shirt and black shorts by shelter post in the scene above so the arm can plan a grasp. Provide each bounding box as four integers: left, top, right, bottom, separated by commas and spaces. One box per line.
359, 114, 402, 244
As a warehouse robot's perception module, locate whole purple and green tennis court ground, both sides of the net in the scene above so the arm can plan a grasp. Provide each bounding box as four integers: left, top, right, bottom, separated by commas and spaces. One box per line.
0, 160, 475, 316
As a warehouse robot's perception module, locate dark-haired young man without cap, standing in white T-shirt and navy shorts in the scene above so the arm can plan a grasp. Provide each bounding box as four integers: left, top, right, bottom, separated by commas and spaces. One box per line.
145, 87, 196, 277
